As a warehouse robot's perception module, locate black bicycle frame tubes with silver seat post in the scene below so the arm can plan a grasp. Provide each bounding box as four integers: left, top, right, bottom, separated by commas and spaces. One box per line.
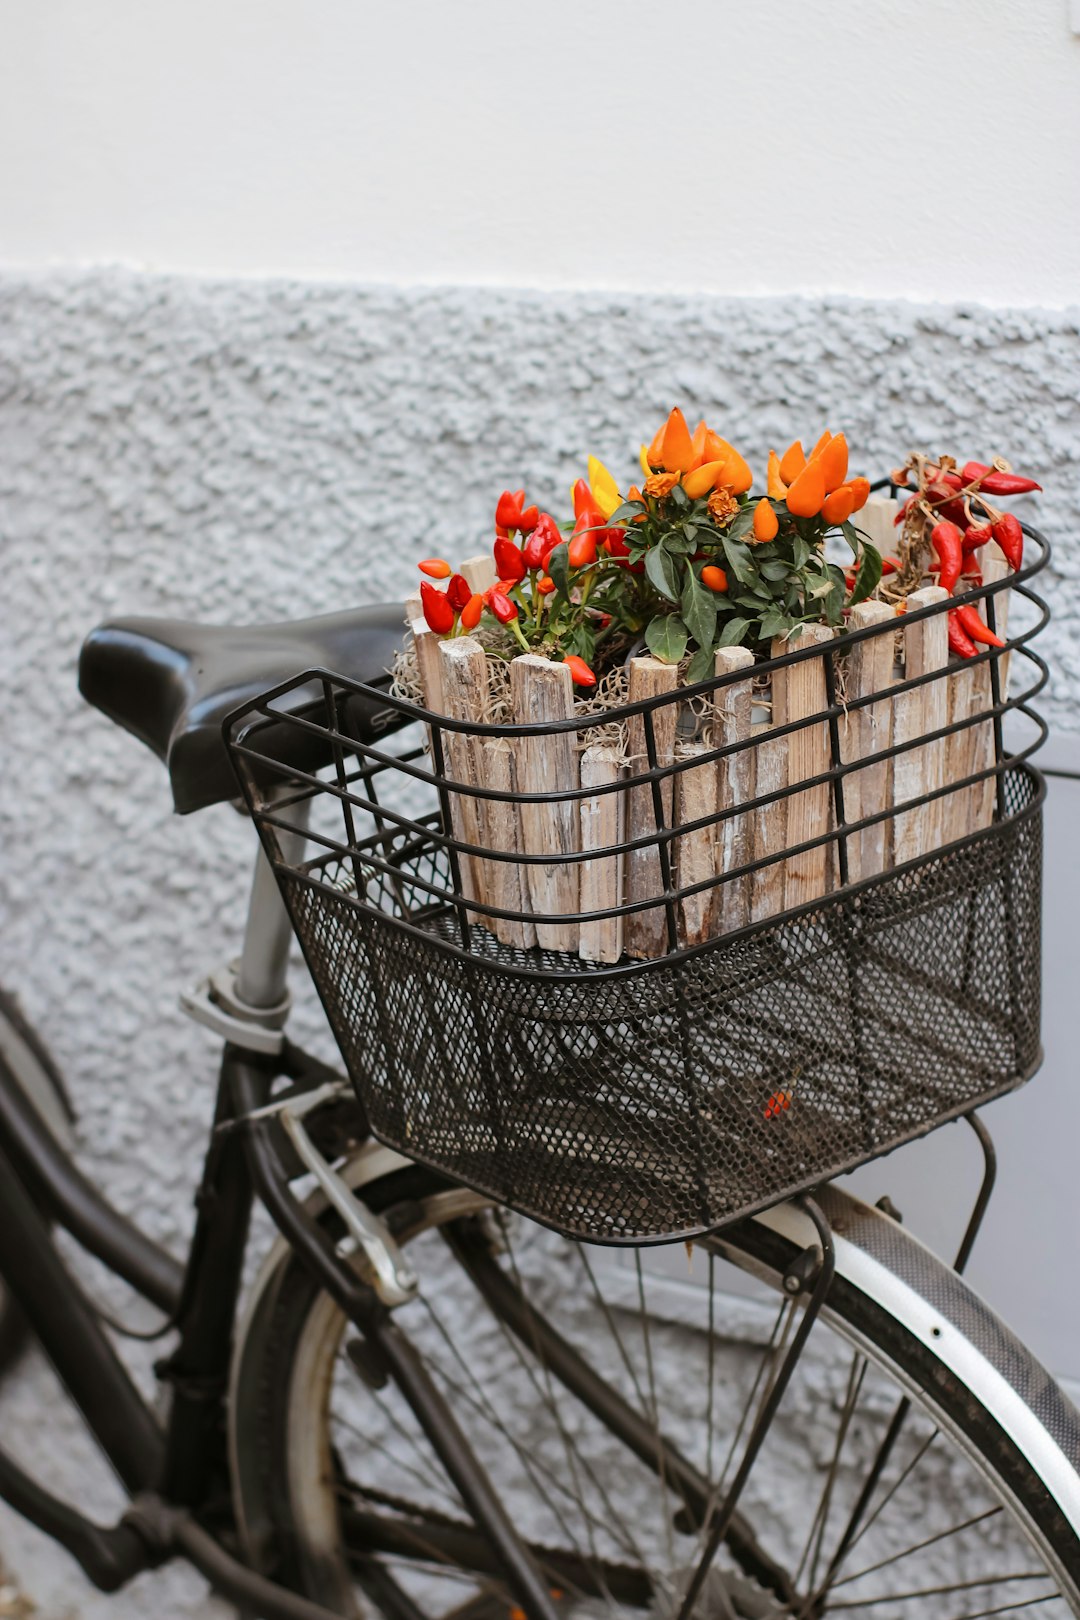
0, 816, 993, 1620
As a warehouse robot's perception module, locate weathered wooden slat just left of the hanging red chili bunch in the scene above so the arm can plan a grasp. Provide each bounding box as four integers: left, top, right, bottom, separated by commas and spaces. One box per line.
892, 585, 949, 865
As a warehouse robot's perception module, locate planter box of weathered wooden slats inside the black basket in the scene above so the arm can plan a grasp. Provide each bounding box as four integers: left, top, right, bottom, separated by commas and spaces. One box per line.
403, 501, 1009, 964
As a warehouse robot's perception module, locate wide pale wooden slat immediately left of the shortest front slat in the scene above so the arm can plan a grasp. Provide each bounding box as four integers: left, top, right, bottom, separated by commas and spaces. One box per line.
510, 653, 580, 951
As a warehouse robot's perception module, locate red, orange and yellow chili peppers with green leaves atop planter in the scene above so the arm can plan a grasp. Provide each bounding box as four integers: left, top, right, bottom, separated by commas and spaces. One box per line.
411, 408, 1040, 689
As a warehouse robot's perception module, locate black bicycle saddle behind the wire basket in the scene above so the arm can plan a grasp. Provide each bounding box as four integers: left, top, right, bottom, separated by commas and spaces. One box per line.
79, 604, 405, 815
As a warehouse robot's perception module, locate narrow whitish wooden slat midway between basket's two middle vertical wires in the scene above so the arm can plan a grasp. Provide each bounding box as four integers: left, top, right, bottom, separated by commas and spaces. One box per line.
712, 646, 756, 933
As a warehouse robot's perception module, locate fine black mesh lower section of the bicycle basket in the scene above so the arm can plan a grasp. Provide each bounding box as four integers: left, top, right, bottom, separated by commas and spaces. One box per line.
282, 771, 1041, 1241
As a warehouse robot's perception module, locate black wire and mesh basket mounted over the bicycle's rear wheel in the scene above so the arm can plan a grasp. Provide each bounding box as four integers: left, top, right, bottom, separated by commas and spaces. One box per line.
227, 530, 1049, 1243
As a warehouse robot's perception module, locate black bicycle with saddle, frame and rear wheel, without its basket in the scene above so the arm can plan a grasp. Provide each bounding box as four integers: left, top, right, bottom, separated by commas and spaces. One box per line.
0, 583, 1080, 1620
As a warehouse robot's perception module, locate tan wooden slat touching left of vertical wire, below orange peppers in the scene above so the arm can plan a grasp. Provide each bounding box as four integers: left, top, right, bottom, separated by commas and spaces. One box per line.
772, 624, 834, 906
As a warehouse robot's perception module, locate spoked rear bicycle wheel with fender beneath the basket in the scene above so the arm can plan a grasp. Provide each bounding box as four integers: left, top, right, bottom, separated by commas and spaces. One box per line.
232, 1170, 1080, 1620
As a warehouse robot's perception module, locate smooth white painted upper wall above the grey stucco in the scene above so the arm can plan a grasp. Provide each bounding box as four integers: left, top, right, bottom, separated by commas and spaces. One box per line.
0, 0, 1080, 306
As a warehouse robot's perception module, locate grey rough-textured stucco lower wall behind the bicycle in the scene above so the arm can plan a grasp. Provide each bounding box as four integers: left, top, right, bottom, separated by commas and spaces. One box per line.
0, 272, 1080, 1620
